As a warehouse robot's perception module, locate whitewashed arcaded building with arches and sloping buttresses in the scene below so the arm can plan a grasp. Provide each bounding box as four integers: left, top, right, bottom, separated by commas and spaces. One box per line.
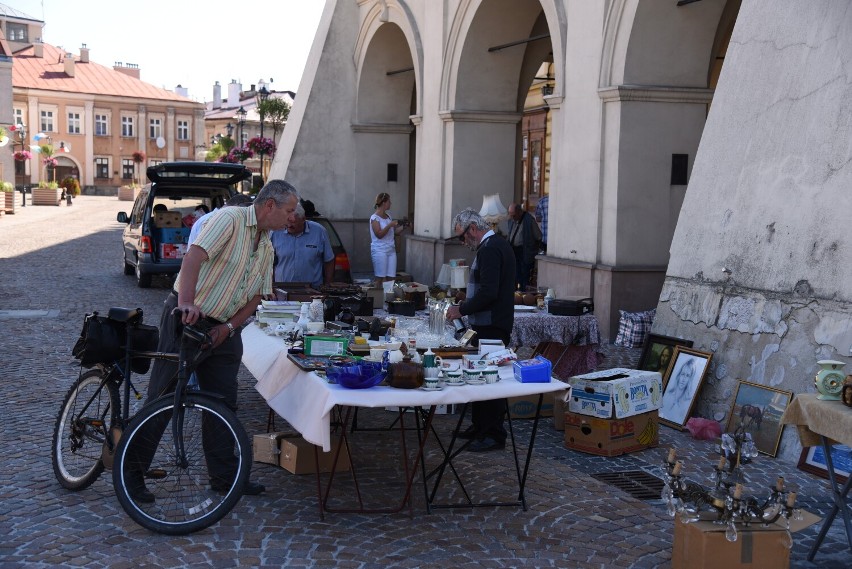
272, 0, 852, 459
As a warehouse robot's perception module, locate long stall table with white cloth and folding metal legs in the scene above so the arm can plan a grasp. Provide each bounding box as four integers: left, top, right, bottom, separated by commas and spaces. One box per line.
243, 324, 565, 512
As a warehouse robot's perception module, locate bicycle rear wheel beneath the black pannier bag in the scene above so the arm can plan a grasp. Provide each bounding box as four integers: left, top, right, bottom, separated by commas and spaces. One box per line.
51, 367, 121, 490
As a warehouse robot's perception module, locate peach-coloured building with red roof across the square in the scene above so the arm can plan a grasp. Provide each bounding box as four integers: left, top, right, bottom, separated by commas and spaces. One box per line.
2, 4, 205, 194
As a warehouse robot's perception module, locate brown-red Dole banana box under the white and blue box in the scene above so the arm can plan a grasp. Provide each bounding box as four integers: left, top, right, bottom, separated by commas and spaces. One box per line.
565, 408, 660, 456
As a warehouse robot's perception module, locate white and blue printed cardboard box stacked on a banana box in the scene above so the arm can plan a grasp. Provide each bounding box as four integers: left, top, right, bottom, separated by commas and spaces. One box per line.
568, 368, 663, 419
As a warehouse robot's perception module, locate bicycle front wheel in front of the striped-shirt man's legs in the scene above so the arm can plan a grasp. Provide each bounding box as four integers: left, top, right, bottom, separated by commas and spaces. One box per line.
112, 393, 252, 535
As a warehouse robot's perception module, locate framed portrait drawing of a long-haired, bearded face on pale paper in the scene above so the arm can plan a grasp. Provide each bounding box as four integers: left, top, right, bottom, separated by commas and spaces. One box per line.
660, 346, 713, 431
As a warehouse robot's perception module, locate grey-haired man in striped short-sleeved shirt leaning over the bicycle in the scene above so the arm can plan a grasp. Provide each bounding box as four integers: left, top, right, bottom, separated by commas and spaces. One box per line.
132, 180, 299, 502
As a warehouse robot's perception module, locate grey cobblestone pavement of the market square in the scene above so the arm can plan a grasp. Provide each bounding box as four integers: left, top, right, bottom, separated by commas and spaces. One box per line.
0, 196, 852, 568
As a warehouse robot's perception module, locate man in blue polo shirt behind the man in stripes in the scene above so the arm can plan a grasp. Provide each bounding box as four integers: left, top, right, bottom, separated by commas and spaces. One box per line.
271, 204, 334, 288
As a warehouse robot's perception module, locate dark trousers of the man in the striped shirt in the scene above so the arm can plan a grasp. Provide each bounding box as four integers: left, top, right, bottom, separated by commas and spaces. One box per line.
135, 292, 243, 483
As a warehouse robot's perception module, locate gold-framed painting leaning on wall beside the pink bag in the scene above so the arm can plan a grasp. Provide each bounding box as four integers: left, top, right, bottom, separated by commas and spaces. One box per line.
725, 381, 793, 457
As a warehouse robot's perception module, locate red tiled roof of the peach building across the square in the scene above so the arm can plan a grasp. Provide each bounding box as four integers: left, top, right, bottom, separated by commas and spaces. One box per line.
12, 43, 194, 102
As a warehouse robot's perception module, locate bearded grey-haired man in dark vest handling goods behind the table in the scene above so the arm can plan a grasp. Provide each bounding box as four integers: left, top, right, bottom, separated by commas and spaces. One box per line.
447, 209, 515, 452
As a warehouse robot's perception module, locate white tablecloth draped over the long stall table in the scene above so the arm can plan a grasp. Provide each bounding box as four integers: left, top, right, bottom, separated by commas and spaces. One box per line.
242, 324, 566, 451
